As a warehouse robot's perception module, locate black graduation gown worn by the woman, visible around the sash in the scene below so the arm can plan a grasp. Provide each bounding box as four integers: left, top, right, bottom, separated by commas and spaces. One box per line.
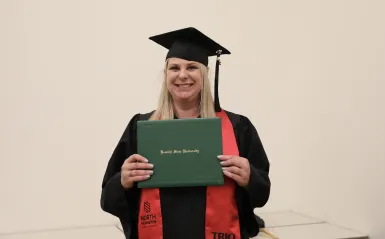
100, 111, 270, 239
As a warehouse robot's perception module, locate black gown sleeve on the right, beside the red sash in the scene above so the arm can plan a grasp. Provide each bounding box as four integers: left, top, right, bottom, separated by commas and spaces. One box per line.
241, 117, 270, 208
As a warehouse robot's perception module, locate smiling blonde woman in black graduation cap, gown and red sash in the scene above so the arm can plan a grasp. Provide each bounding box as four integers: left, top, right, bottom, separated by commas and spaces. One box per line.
101, 28, 270, 239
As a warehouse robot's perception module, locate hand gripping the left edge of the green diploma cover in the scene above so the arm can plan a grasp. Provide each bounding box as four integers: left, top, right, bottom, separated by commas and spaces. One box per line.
120, 154, 154, 189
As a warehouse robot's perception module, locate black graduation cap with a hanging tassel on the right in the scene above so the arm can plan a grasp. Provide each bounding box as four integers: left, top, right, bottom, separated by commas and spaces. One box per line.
150, 27, 231, 112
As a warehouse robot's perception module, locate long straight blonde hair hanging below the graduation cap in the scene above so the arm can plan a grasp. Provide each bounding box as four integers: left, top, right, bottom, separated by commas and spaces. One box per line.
149, 61, 216, 120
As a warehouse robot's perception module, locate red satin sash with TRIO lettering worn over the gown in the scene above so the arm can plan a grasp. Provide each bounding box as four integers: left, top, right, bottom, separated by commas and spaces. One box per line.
138, 110, 241, 239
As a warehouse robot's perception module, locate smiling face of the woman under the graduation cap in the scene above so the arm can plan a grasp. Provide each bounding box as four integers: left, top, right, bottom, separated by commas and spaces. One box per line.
166, 58, 203, 102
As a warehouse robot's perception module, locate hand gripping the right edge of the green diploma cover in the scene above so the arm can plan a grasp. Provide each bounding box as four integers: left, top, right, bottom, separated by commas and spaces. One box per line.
218, 155, 250, 187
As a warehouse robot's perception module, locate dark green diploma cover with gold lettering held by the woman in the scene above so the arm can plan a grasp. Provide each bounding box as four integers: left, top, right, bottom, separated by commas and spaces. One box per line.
137, 118, 224, 188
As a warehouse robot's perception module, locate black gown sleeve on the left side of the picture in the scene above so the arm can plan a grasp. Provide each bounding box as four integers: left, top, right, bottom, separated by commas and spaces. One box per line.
100, 114, 139, 221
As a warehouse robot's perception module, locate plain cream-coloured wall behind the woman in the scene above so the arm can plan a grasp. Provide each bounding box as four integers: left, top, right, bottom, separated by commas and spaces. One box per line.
0, 0, 385, 239
